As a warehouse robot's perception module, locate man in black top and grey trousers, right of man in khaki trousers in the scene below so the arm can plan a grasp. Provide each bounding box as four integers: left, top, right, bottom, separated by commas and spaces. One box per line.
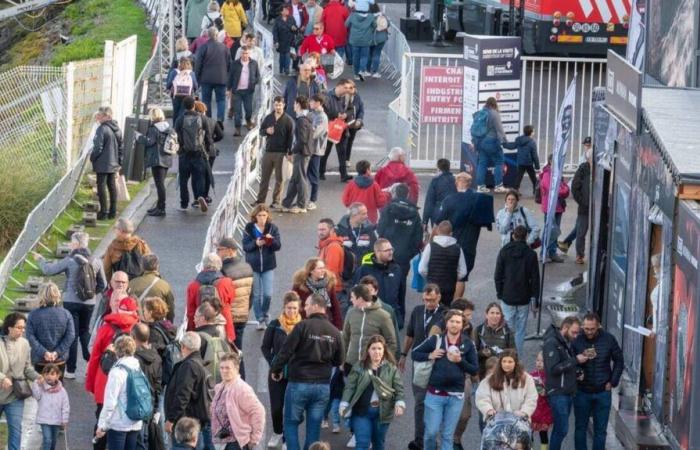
282, 96, 313, 214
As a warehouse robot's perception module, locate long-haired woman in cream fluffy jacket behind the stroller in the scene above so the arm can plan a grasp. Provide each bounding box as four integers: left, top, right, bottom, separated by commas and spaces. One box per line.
476, 349, 537, 421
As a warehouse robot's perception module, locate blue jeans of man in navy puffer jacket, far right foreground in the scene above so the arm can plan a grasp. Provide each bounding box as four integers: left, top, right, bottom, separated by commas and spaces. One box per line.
574, 391, 612, 450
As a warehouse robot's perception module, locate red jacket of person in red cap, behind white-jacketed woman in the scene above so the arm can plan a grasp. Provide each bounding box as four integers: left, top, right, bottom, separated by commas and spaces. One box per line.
85, 313, 139, 405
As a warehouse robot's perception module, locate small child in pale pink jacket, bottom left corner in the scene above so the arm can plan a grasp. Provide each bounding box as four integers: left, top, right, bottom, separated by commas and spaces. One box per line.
32, 364, 70, 450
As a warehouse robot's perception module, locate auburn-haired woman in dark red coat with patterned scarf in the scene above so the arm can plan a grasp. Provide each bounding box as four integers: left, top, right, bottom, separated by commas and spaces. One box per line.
292, 258, 343, 330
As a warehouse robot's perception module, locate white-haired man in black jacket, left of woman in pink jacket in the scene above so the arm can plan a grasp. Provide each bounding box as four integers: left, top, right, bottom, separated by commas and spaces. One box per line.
165, 331, 214, 450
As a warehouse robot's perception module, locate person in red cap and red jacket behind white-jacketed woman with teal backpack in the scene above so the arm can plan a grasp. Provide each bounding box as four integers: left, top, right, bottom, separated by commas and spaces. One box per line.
85, 297, 139, 450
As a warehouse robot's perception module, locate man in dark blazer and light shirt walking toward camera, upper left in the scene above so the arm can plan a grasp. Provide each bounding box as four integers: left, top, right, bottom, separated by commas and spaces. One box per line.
228, 48, 260, 136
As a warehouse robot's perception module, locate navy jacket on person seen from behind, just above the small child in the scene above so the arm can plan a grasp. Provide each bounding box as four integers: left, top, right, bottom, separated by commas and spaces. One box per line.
26, 306, 75, 364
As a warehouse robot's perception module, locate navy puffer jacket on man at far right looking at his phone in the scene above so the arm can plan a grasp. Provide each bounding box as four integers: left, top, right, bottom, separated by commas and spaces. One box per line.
571, 328, 624, 393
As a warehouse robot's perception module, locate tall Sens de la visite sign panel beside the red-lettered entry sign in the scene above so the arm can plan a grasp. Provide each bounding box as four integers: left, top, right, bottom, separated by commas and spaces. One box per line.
460, 34, 522, 178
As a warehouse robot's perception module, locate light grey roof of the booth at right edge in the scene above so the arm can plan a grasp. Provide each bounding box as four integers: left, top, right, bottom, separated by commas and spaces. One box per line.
642, 87, 700, 184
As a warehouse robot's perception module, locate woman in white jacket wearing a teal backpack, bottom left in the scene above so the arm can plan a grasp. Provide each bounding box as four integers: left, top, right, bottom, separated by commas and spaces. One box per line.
95, 336, 143, 450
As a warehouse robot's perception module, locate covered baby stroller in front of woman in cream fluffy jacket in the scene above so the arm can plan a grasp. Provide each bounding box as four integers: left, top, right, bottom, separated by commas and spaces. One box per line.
481, 411, 532, 450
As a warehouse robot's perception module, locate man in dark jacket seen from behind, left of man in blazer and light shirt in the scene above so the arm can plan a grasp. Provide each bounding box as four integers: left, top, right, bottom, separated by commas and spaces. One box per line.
194, 27, 231, 128
